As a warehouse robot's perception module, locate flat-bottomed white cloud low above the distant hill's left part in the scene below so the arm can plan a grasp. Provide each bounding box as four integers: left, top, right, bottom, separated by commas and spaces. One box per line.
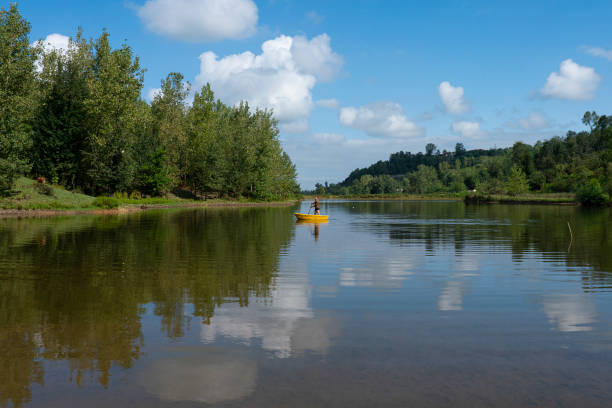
340, 102, 424, 138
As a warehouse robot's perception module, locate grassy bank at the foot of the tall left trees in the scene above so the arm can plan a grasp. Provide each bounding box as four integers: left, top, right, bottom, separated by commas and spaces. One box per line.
0, 177, 294, 217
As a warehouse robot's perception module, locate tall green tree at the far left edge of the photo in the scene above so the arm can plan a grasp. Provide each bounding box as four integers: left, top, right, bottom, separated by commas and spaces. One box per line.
0, 4, 38, 195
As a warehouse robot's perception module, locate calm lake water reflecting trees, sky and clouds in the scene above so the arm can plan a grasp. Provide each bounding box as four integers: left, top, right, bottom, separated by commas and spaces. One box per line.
0, 202, 612, 408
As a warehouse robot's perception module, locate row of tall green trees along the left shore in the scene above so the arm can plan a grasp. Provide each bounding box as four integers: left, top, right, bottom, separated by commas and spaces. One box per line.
0, 4, 299, 199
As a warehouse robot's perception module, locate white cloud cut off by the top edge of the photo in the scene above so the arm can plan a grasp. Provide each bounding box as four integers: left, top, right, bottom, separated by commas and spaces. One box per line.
138, 0, 258, 42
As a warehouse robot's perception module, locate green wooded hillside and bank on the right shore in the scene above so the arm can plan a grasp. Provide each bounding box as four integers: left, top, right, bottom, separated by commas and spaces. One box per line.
310, 112, 612, 205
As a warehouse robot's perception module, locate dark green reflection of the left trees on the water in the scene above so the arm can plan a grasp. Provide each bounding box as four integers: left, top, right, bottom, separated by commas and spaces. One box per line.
0, 209, 292, 406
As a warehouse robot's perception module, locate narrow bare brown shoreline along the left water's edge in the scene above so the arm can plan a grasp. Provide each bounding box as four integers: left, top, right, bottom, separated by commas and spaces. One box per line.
0, 200, 300, 219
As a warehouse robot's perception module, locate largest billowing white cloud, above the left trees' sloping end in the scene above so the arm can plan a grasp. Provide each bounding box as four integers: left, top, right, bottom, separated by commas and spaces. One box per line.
195, 34, 341, 125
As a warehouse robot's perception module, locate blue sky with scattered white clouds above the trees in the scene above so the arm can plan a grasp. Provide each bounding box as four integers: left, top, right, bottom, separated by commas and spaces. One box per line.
13, 0, 612, 189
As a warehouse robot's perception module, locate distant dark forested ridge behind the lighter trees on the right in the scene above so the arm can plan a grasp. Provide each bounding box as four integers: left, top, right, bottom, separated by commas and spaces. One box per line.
340, 143, 508, 186
